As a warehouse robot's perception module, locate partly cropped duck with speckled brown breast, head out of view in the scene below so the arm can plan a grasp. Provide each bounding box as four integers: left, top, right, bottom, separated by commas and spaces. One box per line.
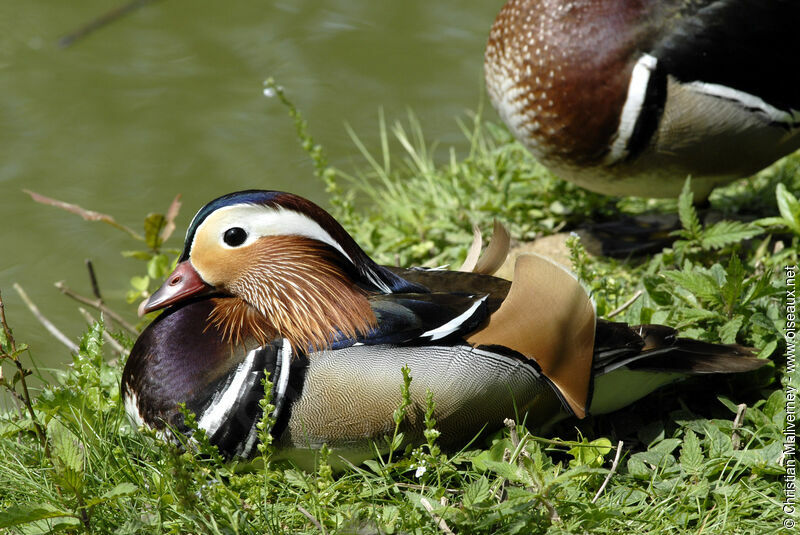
485, 0, 800, 201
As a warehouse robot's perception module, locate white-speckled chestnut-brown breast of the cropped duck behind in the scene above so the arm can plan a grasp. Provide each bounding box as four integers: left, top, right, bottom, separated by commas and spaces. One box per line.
485, 0, 644, 164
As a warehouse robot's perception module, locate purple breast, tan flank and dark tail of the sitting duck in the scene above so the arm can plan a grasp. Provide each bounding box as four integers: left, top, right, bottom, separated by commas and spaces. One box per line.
122, 294, 764, 462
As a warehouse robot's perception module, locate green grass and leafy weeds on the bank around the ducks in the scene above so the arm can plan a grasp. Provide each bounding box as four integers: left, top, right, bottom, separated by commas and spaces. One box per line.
0, 80, 800, 534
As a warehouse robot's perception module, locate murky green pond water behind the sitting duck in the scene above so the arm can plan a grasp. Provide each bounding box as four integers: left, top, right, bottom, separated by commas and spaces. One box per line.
0, 0, 503, 373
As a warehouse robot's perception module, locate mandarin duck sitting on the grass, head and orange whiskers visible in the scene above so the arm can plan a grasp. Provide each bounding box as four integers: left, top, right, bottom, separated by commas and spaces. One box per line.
122, 191, 765, 462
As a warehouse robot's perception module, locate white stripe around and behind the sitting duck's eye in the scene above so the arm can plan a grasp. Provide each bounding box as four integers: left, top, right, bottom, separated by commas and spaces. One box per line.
192, 204, 355, 265
